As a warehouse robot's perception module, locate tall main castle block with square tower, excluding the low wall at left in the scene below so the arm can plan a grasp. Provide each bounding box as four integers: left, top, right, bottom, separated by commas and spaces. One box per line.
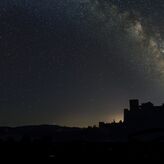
124, 99, 164, 129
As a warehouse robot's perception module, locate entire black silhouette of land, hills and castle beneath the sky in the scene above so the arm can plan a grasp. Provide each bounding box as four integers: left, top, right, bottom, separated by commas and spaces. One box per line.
0, 100, 164, 162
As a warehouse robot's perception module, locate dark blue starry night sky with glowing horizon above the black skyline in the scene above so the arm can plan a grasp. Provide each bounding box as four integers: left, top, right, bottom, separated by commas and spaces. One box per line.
0, 0, 164, 126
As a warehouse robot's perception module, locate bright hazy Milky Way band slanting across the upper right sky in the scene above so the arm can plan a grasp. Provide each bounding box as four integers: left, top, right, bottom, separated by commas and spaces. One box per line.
87, 1, 164, 82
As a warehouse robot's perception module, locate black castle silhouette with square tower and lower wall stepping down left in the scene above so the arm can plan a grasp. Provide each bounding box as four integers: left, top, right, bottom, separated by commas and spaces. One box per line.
99, 99, 164, 134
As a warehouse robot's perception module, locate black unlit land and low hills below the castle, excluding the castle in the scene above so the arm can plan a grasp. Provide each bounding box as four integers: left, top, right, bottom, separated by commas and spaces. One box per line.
0, 125, 164, 164
